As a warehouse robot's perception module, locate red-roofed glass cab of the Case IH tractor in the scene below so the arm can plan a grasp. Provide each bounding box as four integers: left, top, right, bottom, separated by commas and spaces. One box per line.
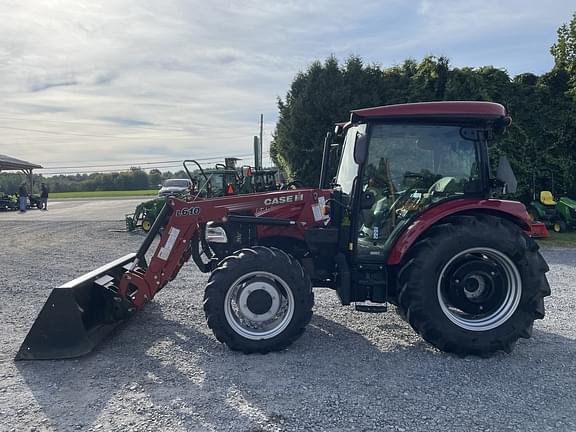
335, 102, 505, 263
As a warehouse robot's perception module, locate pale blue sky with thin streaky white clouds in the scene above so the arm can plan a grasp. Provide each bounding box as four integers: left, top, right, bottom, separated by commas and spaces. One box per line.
0, 0, 576, 175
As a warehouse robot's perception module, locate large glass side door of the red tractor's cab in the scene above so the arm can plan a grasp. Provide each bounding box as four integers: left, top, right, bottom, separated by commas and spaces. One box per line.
356, 124, 482, 255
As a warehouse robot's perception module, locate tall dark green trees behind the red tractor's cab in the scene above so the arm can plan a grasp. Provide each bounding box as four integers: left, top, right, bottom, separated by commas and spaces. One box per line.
271, 13, 576, 199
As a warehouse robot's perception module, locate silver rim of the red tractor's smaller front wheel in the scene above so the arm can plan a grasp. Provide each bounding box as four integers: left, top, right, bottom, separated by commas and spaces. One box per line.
224, 271, 294, 340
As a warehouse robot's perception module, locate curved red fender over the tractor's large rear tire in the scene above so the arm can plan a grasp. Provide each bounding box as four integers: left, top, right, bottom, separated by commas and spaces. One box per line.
387, 199, 530, 265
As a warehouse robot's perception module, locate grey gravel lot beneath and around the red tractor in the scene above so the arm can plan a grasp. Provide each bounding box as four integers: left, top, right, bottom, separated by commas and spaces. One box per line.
0, 220, 576, 432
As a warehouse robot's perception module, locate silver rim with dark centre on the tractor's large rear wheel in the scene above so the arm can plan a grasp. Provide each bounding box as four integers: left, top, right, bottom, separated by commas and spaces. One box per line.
437, 248, 522, 332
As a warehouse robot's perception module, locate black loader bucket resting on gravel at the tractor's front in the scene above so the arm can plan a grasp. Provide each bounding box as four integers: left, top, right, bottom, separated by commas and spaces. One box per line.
15, 253, 136, 360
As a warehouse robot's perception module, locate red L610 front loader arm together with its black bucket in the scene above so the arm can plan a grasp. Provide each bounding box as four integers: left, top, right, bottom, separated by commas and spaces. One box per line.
16, 190, 330, 360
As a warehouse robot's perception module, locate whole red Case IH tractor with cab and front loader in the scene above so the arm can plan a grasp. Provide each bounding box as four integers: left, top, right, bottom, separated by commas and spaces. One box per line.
16, 102, 550, 359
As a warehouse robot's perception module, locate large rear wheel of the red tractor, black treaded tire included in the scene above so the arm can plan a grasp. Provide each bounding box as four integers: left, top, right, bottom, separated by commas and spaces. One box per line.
398, 215, 550, 357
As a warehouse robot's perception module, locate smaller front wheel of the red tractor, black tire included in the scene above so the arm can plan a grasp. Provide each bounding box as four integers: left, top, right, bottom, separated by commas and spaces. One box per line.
204, 246, 314, 354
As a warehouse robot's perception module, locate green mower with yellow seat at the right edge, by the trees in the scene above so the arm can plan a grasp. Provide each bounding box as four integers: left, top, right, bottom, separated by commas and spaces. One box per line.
528, 169, 576, 233
